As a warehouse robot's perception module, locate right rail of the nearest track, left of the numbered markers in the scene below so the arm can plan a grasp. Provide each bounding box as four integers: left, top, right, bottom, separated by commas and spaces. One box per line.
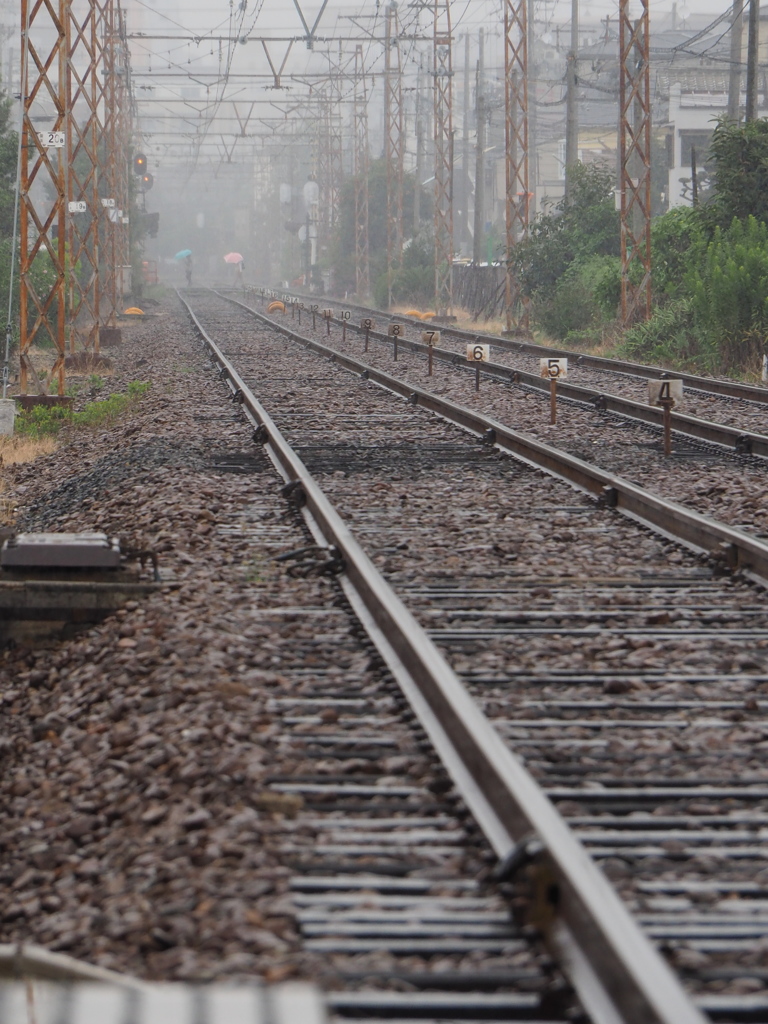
236, 293, 768, 587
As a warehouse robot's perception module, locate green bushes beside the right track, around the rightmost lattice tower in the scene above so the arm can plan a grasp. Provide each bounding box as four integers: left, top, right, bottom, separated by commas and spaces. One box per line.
510, 118, 768, 377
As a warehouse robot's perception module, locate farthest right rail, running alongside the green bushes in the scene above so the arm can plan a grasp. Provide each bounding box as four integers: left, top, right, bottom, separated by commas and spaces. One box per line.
274, 292, 768, 403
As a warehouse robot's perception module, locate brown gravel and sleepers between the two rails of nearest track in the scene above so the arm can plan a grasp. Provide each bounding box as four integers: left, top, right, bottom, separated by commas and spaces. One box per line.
174, 297, 768, 1021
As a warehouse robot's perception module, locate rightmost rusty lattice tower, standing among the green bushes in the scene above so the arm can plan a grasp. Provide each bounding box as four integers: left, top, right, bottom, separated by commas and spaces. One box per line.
618, 0, 651, 326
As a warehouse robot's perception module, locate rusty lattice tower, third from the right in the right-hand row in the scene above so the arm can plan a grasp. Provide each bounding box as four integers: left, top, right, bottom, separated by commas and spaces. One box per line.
432, 0, 454, 315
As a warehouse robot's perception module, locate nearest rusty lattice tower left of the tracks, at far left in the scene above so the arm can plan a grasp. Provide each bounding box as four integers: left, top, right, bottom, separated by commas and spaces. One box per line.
19, 0, 68, 395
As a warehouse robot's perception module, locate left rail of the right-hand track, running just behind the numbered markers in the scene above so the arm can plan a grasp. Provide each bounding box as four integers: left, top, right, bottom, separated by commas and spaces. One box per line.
323, 309, 768, 458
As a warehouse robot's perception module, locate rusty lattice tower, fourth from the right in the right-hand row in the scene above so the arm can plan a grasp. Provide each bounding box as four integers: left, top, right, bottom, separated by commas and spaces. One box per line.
384, 0, 406, 305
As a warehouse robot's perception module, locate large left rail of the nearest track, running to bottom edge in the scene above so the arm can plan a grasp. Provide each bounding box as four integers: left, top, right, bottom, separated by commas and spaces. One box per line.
181, 290, 705, 1024
